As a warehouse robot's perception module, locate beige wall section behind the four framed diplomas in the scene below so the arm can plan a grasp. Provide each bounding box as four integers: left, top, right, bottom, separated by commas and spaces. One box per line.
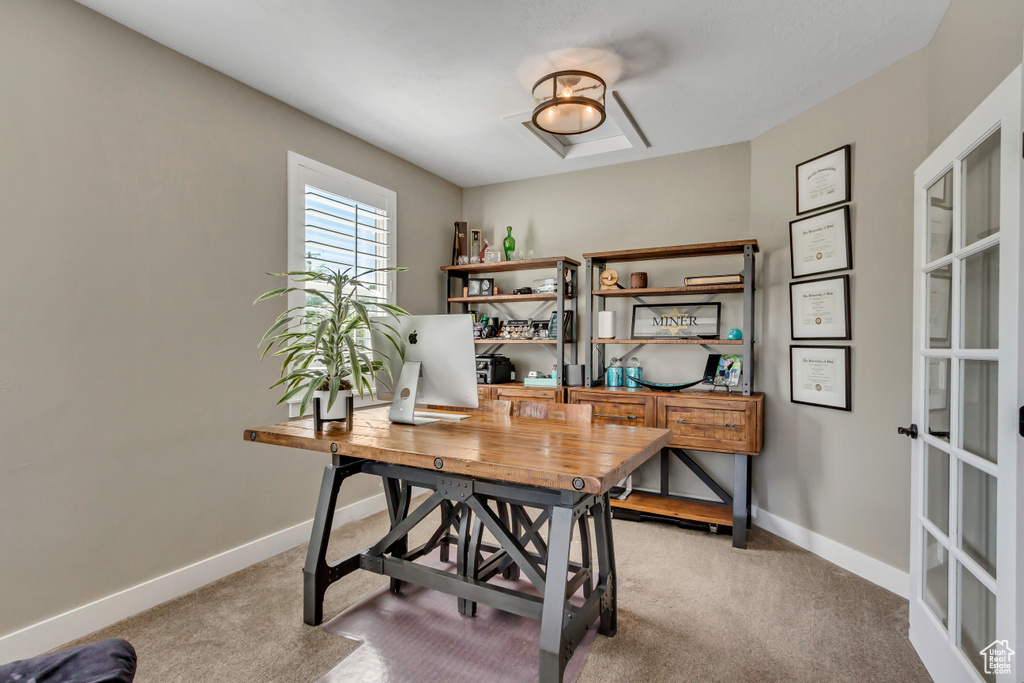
751, 51, 928, 570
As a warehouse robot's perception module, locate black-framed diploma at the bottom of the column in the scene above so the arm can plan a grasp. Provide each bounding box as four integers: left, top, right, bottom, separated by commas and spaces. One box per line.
790, 346, 851, 411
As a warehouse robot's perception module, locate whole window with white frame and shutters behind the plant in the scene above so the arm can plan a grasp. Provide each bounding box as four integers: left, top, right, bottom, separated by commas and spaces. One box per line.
288, 152, 396, 417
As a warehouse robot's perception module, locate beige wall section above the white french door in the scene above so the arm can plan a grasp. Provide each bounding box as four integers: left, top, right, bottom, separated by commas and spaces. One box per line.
928, 0, 1024, 150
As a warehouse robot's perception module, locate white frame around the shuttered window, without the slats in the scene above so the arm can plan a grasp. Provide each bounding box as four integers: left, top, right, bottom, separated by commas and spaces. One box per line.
287, 151, 398, 418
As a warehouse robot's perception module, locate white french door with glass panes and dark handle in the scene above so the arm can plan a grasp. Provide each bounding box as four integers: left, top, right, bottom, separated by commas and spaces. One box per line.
910, 67, 1024, 683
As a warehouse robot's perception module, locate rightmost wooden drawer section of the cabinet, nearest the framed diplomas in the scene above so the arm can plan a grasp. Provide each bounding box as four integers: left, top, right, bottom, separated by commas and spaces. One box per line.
658, 397, 762, 455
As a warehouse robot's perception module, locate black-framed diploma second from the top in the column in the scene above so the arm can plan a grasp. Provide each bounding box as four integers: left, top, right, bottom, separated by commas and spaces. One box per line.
790, 206, 853, 278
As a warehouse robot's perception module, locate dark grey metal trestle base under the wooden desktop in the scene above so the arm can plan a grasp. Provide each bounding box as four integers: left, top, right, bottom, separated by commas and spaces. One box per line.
303, 456, 616, 683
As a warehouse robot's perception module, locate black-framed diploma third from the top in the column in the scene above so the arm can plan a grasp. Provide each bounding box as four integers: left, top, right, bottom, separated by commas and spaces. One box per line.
790, 275, 851, 339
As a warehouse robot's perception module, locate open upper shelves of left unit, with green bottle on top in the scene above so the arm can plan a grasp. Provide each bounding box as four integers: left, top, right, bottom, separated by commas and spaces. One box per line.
441, 256, 580, 388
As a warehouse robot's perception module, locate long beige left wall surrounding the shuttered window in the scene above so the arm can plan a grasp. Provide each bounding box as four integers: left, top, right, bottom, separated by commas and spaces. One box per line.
0, 0, 462, 635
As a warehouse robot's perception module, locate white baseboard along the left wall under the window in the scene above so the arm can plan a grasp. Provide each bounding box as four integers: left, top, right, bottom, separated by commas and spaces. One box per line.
0, 494, 387, 664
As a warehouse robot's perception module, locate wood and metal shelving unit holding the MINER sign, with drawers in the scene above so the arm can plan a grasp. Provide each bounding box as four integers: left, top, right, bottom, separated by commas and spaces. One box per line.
570, 240, 763, 548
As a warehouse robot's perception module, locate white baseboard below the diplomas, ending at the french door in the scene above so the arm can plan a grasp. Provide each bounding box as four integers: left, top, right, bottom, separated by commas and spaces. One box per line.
752, 508, 910, 599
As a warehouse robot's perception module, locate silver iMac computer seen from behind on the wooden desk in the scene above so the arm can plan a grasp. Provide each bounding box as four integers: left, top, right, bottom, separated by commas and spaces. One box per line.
373, 315, 479, 425
